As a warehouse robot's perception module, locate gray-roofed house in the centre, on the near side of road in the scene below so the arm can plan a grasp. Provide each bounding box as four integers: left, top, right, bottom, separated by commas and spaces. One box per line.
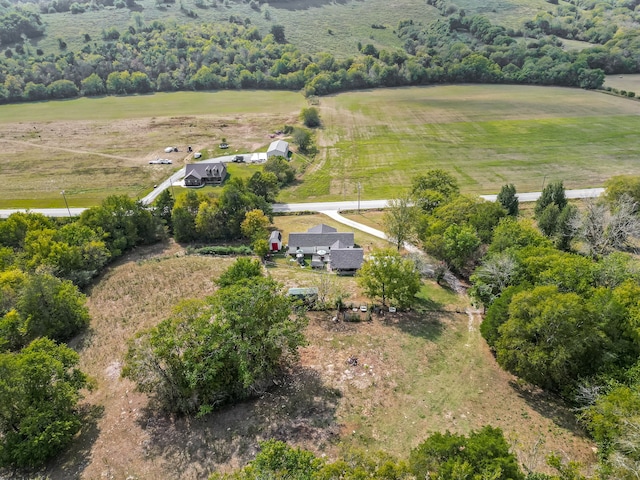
288, 224, 364, 273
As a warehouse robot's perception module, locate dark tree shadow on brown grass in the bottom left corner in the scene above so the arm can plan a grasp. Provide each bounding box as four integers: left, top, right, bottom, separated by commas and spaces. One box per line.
43, 404, 104, 480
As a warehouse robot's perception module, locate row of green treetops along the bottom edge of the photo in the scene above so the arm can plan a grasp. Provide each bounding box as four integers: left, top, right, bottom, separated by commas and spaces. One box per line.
209, 426, 584, 480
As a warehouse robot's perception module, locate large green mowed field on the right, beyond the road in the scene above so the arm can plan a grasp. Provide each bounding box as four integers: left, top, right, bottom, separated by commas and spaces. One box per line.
281, 85, 640, 201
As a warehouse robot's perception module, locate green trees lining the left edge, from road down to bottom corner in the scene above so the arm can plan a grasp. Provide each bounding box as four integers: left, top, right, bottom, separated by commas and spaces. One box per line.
0, 196, 169, 467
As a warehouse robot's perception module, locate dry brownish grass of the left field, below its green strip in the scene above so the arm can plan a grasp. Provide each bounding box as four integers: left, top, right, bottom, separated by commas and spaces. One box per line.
0, 112, 297, 208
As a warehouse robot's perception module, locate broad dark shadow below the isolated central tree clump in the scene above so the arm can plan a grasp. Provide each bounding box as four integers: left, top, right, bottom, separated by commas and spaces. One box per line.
139, 367, 340, 478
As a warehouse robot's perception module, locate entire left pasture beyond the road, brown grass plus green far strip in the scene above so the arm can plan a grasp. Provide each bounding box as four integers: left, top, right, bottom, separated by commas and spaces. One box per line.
0, 91, 304, 208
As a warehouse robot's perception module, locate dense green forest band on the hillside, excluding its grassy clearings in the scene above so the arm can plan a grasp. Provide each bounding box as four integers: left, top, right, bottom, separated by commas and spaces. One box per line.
0, 0, 640, 102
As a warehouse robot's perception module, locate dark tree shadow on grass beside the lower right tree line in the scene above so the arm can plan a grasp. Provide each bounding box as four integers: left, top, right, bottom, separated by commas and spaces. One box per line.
509, 380, 587, 437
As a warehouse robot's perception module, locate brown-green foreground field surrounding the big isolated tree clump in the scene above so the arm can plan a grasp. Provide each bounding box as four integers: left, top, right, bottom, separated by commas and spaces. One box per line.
41, 237, 595, 480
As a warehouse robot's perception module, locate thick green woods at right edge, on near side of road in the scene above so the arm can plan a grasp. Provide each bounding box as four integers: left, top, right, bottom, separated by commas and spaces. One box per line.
470, 177, 640, 478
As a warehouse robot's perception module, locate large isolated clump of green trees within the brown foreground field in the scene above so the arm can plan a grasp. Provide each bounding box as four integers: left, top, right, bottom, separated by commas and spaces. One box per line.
123, 258, 306, 415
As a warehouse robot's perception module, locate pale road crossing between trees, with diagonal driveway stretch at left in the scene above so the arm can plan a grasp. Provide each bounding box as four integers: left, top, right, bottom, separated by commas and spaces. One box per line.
0, 188, 604, 218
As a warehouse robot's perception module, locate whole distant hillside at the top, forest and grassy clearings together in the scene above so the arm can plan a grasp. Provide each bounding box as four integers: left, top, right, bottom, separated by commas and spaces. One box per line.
0, 0, 640, 102
